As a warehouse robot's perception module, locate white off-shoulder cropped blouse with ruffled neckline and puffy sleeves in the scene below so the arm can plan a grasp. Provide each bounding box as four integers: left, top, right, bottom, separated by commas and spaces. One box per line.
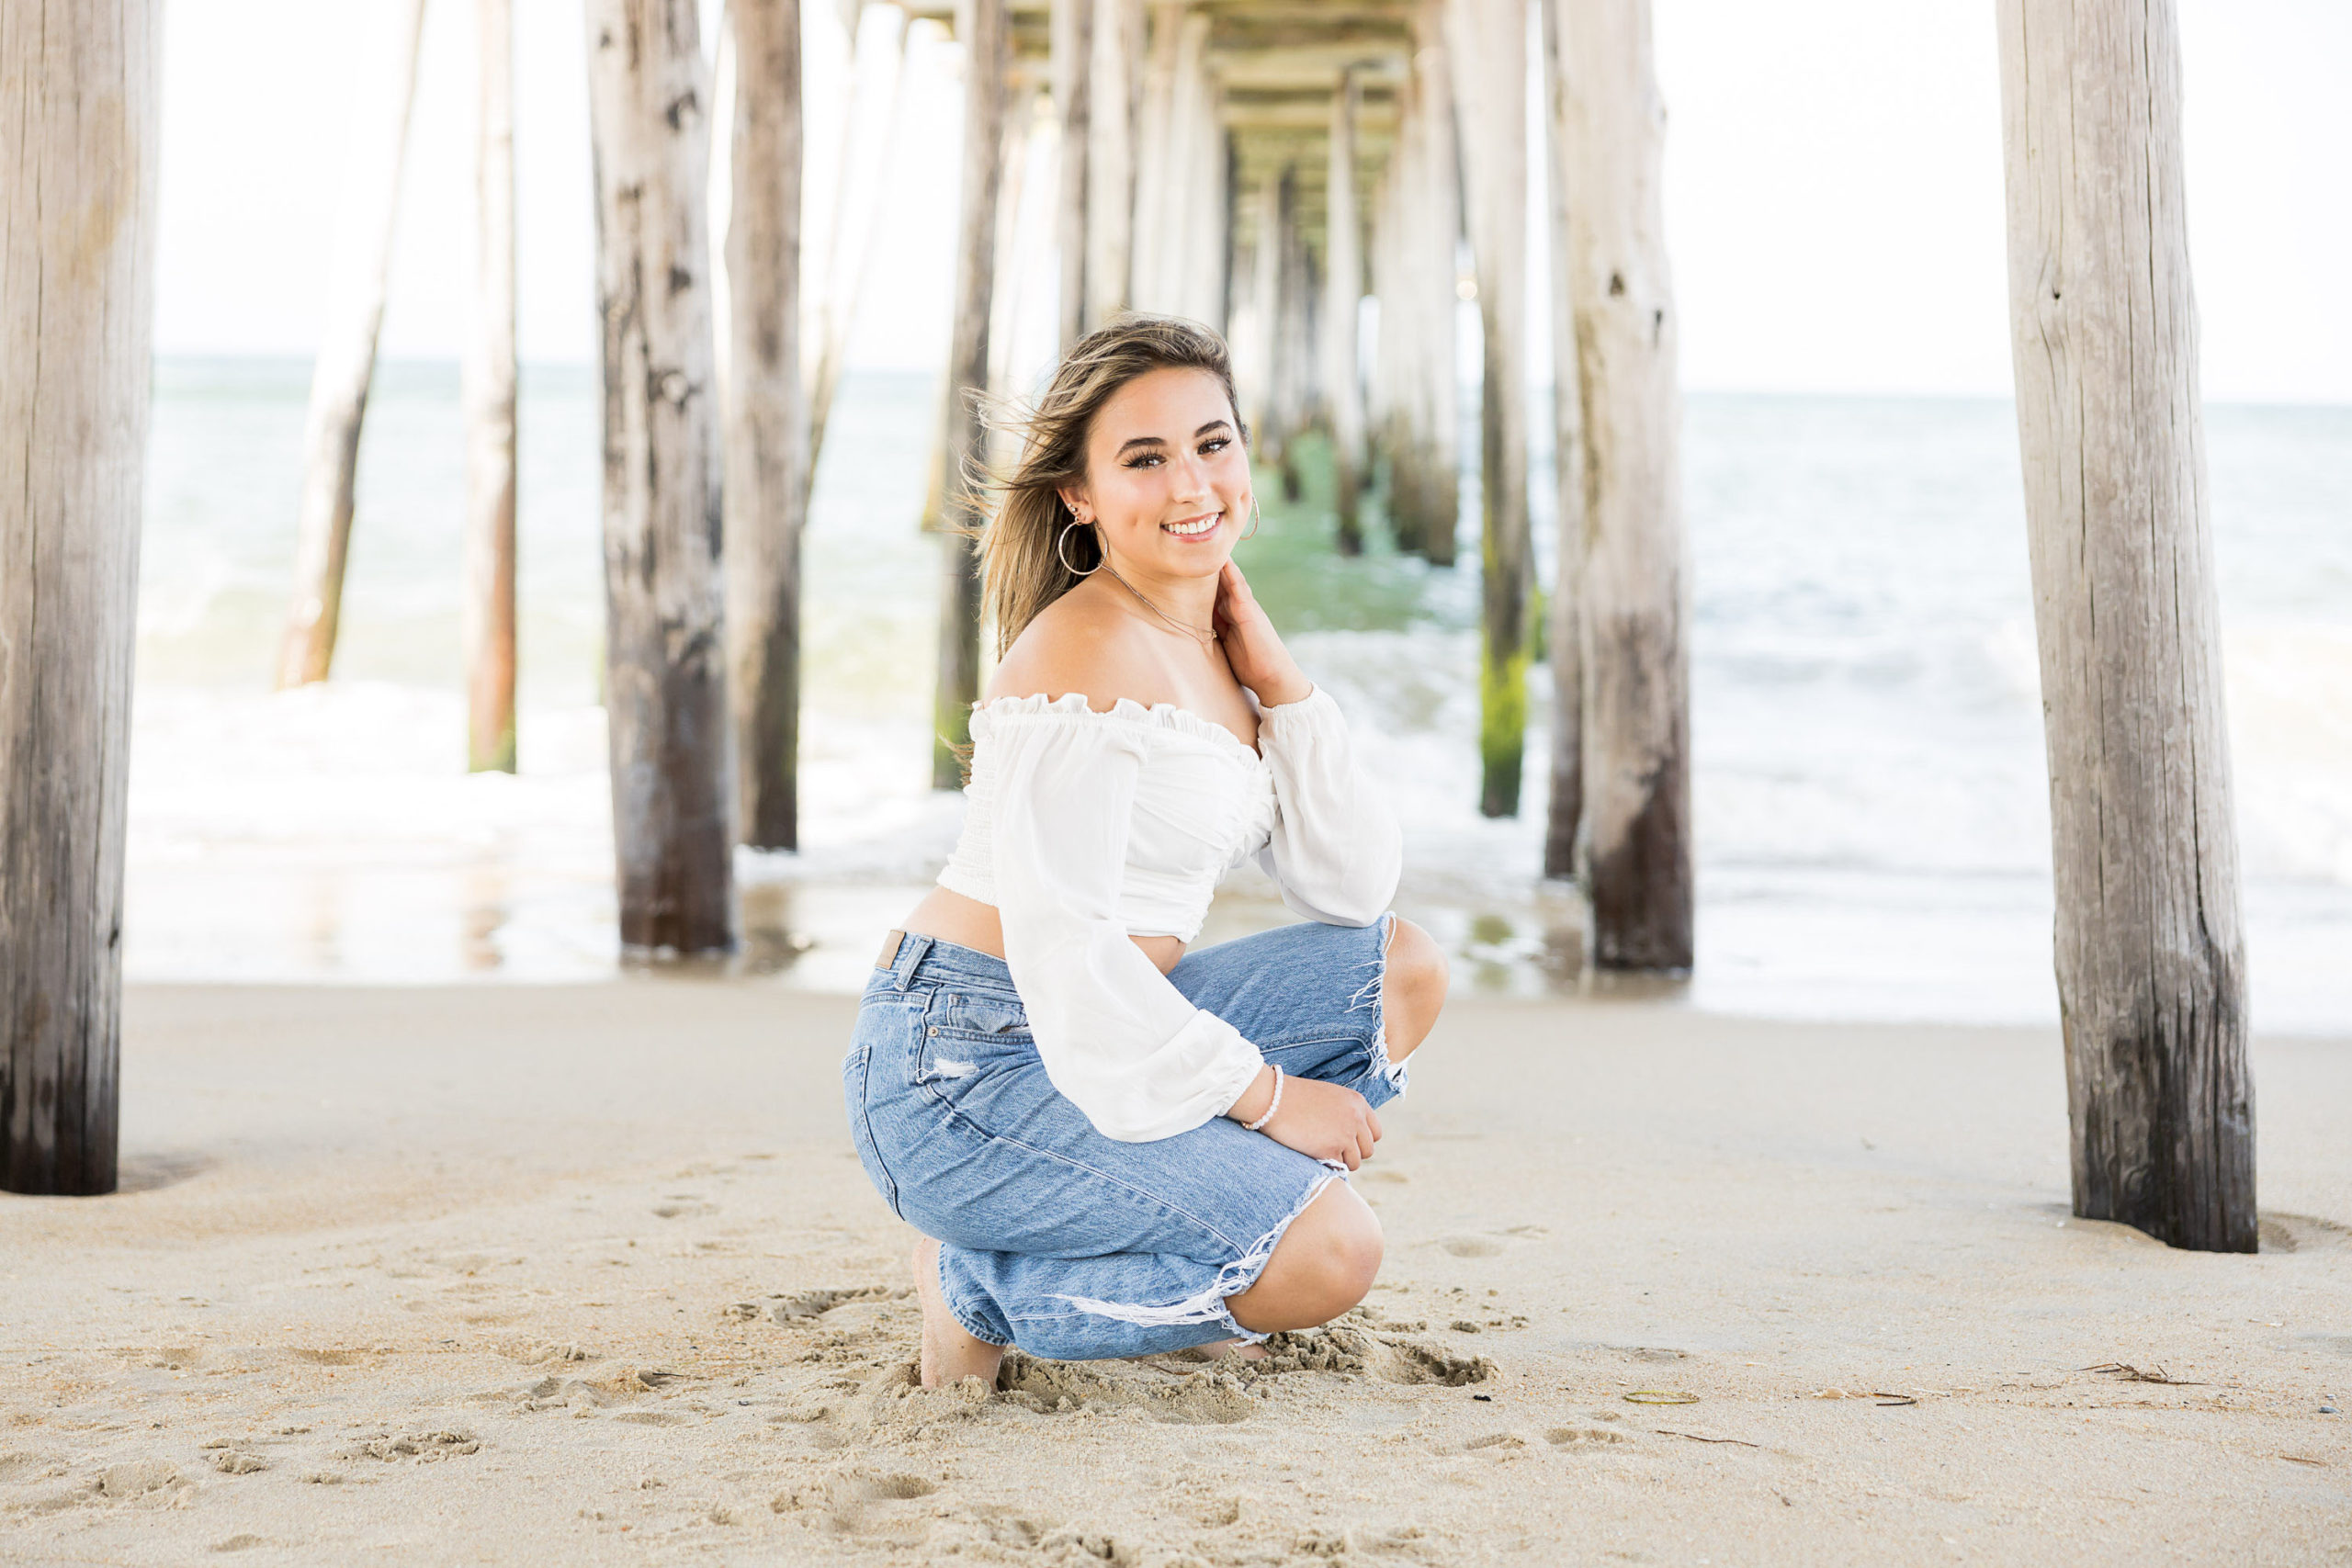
938, 686, 1404, 1143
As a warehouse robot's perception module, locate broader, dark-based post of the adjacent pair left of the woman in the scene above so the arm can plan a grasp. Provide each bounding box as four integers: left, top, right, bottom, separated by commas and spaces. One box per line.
588, 0, 734, 954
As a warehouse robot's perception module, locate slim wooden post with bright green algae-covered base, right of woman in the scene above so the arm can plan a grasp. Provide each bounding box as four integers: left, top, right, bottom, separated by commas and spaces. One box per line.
1453, 0, 1533, 816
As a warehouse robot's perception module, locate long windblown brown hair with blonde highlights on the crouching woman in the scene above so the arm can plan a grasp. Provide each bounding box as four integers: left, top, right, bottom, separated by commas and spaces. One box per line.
957, 312, 1249, 659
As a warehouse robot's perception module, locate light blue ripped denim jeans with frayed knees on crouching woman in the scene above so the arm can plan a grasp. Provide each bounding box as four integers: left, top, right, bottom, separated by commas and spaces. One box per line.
842, 912, 1404, 1361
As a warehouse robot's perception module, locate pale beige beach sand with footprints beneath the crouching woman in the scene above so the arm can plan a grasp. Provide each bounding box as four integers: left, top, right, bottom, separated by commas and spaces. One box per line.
0, 980, 2352, 1568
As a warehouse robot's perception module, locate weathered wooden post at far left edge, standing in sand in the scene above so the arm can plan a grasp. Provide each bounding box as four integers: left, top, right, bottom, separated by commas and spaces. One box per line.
0, 0, 163, 1197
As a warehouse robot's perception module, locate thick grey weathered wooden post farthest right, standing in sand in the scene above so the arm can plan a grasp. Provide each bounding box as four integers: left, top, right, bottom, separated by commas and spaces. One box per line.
1996, 0, 2256, 1253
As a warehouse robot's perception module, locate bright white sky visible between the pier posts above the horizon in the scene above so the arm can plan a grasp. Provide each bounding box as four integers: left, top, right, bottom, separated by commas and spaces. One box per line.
158, 0, 2352, 402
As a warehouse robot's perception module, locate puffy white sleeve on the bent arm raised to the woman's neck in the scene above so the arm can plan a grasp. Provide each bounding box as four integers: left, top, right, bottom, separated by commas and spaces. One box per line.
1259, 686, 1404, 926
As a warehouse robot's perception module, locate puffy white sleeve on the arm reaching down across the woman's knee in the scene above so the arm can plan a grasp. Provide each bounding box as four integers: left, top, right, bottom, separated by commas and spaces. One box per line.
990, 715, 1265, 1143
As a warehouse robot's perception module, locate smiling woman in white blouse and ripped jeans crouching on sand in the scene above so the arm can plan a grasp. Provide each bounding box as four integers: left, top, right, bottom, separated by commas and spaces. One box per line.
842, 315, 1444, 1384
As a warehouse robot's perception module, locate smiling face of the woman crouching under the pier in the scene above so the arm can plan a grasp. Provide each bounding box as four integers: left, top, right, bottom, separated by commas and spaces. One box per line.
1061, 369, 1251, 579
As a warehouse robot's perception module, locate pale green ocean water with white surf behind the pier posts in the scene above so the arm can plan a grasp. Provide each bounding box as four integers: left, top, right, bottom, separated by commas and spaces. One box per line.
125, 360, 2352, 1032
